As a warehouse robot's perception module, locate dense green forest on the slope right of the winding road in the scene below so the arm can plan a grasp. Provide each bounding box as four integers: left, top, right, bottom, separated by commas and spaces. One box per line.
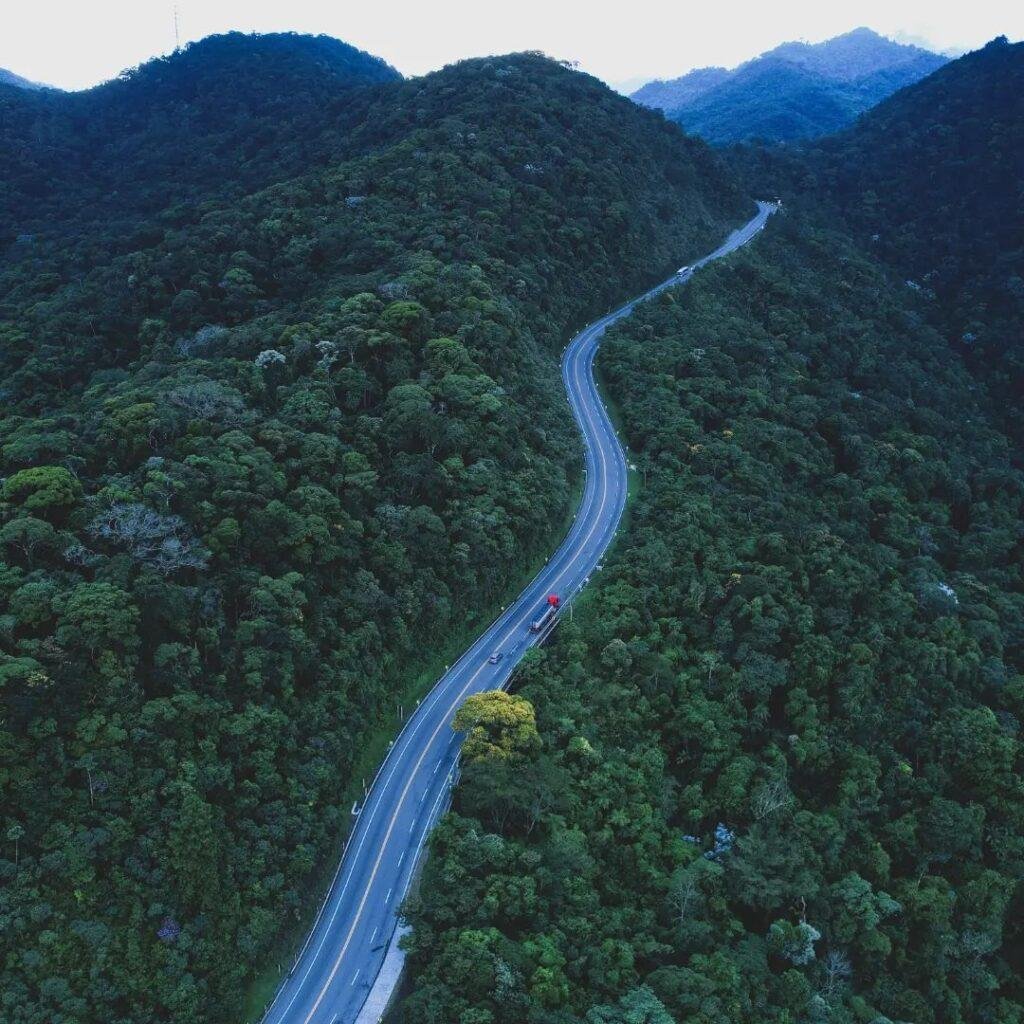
396, 210, 1024, 1024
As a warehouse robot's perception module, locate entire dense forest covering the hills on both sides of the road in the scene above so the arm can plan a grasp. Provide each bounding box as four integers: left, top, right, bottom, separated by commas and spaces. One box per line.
0, 22, 1024, 1024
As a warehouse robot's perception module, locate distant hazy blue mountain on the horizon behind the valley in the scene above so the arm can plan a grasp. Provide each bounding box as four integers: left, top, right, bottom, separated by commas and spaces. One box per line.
632, 29, 946, 143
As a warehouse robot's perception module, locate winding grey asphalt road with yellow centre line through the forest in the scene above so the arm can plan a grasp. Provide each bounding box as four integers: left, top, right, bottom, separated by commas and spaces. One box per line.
263, 203, 776, 1024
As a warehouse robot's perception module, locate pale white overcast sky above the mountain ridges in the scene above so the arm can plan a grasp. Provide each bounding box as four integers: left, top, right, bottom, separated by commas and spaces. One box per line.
0, 0, 1024, 89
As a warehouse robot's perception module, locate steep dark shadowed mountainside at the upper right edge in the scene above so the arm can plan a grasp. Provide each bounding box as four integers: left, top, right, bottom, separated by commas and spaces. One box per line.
811, 39, 1024, 437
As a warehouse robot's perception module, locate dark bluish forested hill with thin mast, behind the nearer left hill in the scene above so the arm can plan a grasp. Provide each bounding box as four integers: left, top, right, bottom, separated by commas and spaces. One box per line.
0, 33, 401, 235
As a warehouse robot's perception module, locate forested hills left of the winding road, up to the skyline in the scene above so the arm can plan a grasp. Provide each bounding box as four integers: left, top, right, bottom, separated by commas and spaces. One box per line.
0, 37, 753, 1024
